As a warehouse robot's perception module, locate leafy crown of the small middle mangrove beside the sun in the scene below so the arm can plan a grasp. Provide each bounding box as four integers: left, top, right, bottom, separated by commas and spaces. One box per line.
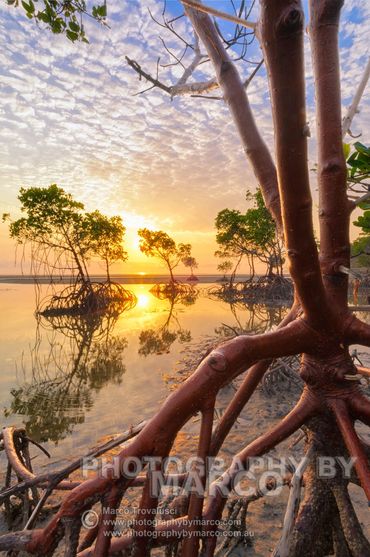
138, 228, 191, 281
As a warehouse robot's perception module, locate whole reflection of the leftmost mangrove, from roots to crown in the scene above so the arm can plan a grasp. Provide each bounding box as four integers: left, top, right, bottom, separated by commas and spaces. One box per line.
4, 312, 127, 443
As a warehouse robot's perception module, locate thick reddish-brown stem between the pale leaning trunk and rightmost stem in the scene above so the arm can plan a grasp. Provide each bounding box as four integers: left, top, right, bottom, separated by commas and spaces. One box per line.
258, 0, 331, 328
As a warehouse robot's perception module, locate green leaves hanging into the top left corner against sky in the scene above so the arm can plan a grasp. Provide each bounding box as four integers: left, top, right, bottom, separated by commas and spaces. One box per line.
6, 0, 107, 42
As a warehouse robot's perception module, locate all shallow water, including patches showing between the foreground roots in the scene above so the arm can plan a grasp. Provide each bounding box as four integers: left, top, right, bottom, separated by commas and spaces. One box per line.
0, 283, 370, 557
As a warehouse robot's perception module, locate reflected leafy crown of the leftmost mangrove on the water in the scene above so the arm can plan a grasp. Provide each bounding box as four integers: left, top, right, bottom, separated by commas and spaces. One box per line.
3, 328, 127, 443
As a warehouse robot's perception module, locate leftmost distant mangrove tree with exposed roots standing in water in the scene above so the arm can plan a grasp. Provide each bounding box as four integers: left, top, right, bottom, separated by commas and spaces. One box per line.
4, 184, 135, 316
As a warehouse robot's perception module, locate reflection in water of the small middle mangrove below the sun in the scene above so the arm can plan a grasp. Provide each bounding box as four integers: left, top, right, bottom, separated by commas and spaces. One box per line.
139, 283, 199, 356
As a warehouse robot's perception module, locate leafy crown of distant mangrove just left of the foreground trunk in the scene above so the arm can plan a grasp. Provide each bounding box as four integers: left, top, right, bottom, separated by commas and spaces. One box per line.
215, 190, 282, 270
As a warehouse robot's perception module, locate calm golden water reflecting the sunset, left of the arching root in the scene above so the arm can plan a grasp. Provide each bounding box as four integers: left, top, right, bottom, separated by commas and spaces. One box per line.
0, 283, 282, 462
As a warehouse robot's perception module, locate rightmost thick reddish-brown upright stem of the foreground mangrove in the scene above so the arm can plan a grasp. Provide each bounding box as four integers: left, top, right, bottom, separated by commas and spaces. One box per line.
310, 0, 350, 308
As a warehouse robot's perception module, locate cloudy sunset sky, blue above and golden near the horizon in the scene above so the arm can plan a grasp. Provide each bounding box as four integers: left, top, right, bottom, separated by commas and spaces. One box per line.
0, 0, 370, 274
